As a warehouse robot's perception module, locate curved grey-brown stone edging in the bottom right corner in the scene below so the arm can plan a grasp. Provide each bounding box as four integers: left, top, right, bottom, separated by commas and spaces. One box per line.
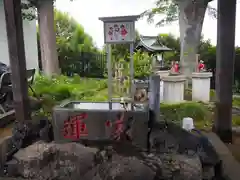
204, 132, 240, 180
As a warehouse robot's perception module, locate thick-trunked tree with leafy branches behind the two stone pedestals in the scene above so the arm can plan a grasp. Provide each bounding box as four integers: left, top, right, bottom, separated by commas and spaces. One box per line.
142, 0, 216, 76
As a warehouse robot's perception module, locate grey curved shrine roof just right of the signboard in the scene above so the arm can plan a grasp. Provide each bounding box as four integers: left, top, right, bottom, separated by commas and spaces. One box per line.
136, 36, 172, 52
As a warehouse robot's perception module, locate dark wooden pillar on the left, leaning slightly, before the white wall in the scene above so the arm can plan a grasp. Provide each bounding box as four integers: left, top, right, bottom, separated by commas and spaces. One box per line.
4, 0, 30, 122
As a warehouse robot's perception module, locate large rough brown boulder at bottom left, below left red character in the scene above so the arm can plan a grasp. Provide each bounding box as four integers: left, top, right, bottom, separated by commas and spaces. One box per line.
9, 142, 97, 180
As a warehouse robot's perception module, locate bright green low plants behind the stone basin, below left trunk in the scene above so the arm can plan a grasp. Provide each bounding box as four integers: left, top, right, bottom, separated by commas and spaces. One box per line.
30, 75, 107, 116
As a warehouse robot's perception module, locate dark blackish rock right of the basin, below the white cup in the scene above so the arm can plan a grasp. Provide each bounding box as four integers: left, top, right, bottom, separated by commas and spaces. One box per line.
150, 122, 220, 166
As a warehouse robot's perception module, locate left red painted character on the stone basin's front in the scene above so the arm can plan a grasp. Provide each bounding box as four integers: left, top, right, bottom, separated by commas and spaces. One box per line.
63, 113, 88, 140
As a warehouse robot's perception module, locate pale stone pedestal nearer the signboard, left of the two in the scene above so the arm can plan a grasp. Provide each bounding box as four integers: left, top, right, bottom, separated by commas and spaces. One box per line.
162, 75, 186, 103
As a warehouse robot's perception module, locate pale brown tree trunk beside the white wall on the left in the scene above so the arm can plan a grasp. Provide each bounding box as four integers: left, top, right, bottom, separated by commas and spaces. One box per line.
37, 0, 60, 76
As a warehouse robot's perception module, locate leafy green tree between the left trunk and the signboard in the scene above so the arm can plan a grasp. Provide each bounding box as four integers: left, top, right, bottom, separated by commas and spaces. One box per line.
51, 10, 105, 76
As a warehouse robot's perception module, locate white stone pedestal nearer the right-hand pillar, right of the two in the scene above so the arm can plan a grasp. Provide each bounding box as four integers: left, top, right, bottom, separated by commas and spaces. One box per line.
192, 72, 212, 102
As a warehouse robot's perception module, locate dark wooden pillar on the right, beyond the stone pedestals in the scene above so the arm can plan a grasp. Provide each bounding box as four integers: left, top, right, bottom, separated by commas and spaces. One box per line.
213, 0, 236, 142
